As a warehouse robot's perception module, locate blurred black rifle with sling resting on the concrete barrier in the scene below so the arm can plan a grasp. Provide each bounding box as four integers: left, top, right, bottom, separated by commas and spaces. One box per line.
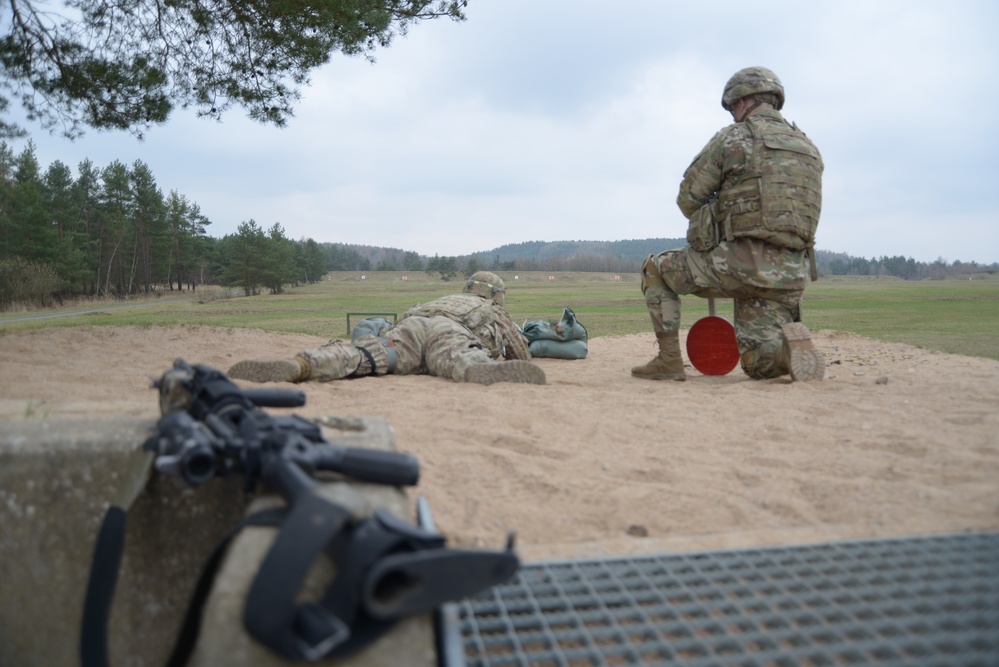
81, 359, 519, 667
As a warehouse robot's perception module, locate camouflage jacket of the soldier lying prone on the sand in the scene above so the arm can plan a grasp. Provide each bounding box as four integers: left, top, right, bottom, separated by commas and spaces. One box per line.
399, 293, 531, 359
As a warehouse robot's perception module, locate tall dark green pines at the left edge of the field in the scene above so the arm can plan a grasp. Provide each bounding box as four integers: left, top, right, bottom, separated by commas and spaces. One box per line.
0, 142, 344, 308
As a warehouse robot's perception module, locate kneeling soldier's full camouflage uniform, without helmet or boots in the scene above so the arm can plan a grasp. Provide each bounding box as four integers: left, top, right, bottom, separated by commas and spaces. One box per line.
642, 109, 823, 379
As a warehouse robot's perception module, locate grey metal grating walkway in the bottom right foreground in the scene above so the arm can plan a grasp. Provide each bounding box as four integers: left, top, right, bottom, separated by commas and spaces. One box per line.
441, 533, 999, 667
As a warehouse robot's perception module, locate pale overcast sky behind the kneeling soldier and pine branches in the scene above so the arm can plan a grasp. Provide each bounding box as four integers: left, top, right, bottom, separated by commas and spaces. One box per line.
13, 0, 999, 263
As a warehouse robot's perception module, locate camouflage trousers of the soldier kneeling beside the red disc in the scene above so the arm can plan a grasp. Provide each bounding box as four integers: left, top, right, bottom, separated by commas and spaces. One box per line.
642, 238, 808, 380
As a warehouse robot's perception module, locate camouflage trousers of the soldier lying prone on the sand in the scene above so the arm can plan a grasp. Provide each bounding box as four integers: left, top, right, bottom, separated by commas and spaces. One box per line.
298, 316, 493, 382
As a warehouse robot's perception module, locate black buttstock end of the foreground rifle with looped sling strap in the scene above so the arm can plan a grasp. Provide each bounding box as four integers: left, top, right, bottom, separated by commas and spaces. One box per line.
243, 492, 508, 661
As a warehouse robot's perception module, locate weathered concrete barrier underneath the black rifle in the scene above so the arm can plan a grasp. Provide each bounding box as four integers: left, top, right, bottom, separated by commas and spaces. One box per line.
0, 417, 435, 667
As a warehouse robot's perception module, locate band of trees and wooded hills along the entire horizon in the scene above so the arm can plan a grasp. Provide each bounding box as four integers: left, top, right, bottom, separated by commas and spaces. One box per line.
0, 142, 999, 310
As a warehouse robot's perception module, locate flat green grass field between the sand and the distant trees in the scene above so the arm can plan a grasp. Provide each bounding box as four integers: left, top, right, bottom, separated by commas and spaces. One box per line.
0, 272, 999, 360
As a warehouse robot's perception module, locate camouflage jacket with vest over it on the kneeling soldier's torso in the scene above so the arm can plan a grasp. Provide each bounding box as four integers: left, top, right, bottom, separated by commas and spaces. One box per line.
676, 109, 823, 250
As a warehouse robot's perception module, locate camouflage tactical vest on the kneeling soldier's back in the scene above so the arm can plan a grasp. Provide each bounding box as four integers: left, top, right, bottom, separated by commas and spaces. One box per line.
718, 116, 823, 250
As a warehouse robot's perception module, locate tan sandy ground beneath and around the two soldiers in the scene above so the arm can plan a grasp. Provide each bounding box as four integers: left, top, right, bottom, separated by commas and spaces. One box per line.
0, 327, 999, 560
